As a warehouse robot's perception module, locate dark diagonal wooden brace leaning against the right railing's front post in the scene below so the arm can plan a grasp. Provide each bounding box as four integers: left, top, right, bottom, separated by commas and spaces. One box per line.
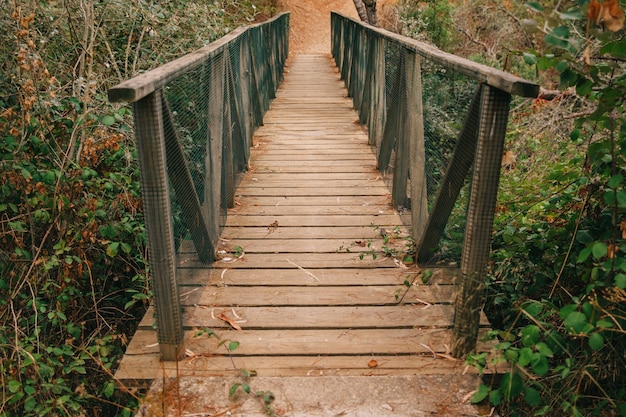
416, 84, 486, 263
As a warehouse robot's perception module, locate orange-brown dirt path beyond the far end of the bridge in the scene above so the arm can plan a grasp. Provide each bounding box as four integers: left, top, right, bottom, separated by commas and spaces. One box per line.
280, 0, 359, 54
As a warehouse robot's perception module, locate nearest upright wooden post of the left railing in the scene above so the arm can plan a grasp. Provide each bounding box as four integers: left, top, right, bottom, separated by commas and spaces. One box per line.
134, 90, 184, 361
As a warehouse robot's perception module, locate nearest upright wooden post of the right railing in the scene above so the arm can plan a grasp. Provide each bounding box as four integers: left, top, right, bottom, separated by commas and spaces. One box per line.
452, 86, 511, 357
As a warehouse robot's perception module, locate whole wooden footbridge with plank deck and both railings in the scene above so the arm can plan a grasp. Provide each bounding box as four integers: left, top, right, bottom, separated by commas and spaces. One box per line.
109, 14, 537, 415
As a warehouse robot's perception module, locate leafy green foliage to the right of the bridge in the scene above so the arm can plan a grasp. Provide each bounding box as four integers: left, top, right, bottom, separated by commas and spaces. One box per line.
470, 2, 626, 416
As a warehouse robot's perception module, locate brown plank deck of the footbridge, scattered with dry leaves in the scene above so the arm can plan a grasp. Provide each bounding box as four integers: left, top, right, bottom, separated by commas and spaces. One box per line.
116, 55, 487, 383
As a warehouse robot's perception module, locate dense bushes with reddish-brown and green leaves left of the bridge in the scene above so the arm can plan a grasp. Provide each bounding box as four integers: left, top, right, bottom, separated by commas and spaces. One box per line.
0, 0, 272, 416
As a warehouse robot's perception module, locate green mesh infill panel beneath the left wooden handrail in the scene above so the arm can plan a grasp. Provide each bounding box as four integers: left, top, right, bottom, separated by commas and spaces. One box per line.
164, 17, 287, 259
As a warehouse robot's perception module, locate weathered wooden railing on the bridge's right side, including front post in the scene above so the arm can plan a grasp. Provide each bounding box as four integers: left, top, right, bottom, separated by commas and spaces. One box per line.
331, 13, 539, 357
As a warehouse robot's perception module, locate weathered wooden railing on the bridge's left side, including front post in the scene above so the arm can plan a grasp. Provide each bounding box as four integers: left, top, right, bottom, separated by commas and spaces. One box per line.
108, 13, 289, 360
